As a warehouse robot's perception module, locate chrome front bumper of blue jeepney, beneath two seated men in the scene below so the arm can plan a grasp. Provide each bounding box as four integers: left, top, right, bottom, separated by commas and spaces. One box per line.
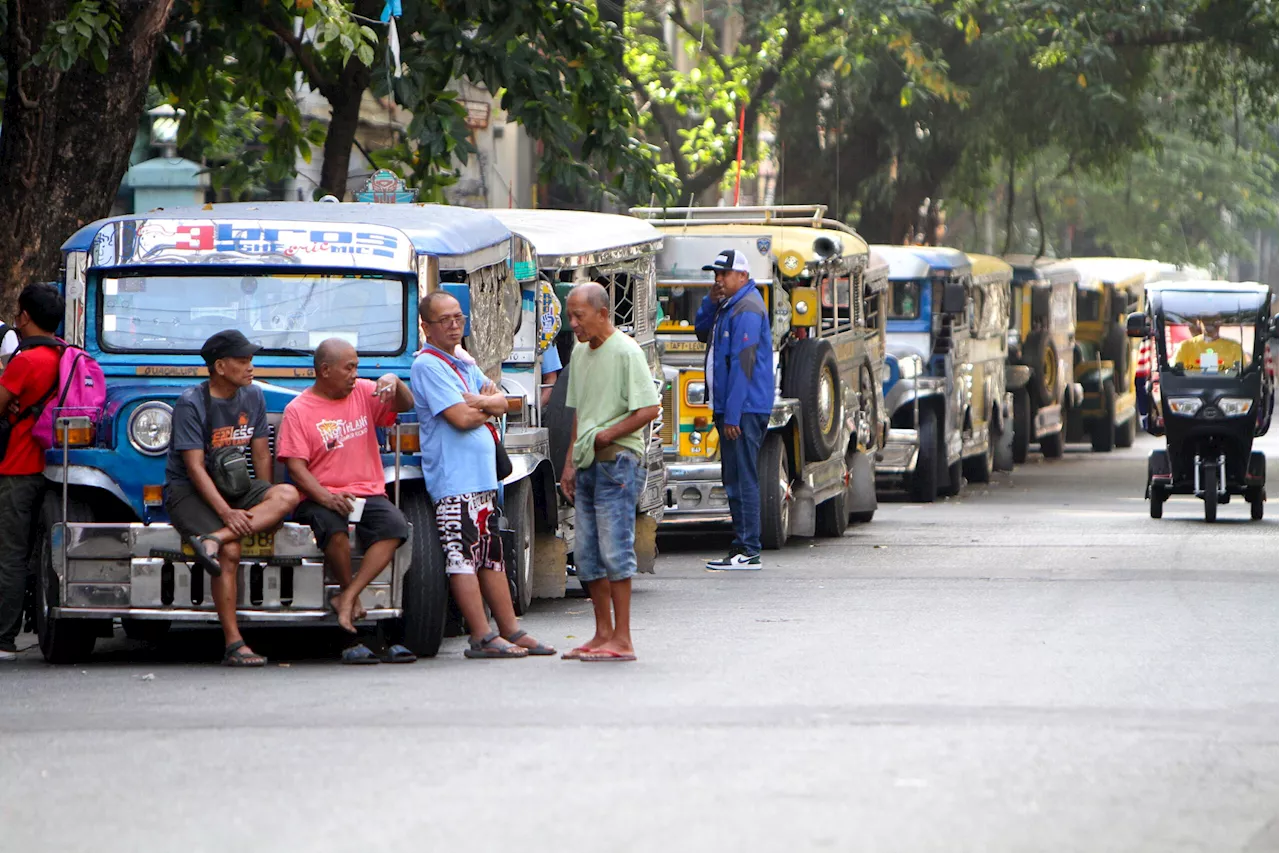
50, 524, 413, 625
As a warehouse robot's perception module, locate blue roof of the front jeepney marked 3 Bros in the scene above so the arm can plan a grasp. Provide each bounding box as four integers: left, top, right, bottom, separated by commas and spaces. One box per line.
63, 201, 511, 269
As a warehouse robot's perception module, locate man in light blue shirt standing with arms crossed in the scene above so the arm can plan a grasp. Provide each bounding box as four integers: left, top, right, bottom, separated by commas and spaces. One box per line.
410, 291, 556, 658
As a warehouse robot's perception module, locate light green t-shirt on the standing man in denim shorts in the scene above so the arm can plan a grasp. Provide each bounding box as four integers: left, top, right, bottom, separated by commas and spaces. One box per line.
564, 332, 662, 469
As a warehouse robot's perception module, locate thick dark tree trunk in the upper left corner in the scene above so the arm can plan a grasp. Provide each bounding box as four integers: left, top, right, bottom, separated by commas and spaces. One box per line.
0, 0, 173, 315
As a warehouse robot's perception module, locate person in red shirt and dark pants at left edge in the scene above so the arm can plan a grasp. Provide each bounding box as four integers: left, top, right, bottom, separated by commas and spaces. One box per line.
0, 283, 65, 661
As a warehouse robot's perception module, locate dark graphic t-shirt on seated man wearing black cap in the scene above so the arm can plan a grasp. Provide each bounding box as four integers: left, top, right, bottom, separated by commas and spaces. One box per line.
165, 386, 268, 484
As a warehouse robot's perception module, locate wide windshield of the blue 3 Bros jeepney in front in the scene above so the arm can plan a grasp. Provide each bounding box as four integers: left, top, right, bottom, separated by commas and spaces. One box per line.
99, 273, 406, 355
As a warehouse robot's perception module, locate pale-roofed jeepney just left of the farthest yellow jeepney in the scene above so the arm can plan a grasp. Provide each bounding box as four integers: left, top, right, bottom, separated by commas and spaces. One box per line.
1006, 255, 1084, 465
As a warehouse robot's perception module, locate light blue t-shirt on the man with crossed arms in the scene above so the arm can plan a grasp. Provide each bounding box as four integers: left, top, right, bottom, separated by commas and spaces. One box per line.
410, 347, 498, 501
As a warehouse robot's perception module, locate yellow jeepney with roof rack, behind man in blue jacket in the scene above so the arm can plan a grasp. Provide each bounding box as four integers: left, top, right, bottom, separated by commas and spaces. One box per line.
632, 205, 884, 540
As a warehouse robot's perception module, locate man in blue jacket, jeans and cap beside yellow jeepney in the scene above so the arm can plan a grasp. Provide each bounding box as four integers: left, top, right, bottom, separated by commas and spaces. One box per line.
694, 248, 773, 570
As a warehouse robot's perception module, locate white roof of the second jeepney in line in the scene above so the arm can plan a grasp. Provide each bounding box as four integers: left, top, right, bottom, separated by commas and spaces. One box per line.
489, 209, 662, 269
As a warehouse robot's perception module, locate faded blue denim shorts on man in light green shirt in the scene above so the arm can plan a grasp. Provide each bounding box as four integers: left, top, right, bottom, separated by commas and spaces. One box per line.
573, 451, 645, 584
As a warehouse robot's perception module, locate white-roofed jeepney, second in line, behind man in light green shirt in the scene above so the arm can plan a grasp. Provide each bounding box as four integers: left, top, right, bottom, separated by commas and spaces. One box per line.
490, 209, 666, 607
